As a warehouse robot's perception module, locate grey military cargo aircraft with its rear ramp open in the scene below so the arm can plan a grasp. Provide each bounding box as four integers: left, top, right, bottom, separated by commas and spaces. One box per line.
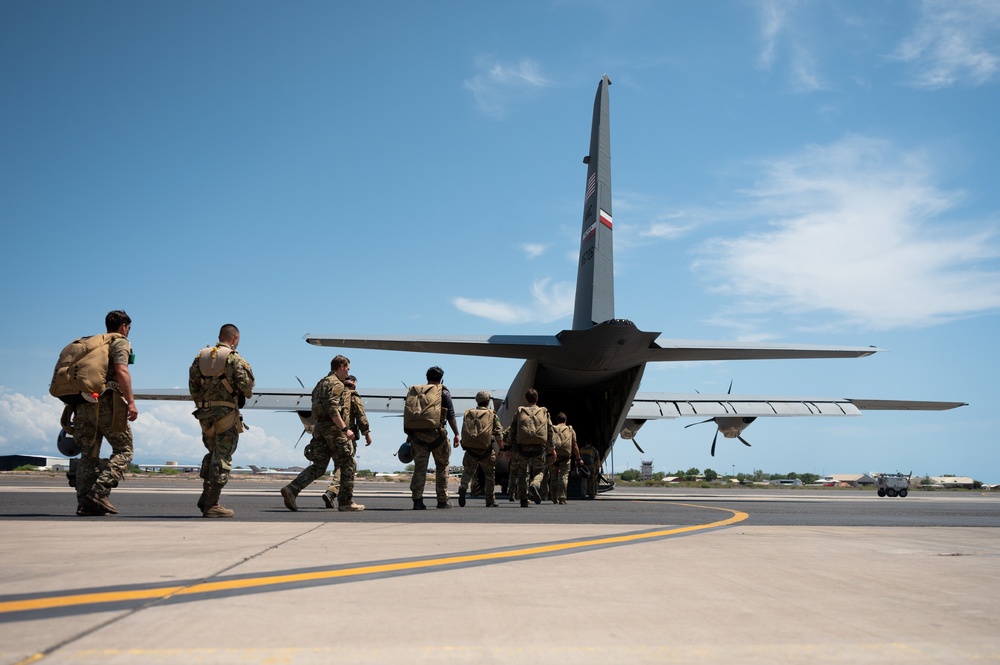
136, 75, 964, 496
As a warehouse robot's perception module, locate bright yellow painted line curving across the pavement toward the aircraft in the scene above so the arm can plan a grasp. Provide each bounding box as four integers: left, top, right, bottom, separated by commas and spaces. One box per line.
0, 504, 749, 614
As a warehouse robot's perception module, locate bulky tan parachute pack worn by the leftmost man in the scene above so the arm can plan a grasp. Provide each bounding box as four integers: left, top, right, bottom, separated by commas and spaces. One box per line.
49, 333, 122, 404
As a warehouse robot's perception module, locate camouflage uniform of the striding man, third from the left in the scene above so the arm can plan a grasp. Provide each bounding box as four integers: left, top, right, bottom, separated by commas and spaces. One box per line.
286, 372, 355, 510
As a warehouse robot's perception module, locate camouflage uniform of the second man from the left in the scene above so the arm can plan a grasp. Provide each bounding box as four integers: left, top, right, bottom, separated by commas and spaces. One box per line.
188, 342, 254, 491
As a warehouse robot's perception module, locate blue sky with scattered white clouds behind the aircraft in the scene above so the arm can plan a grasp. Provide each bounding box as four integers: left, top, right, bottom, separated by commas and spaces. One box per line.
0, 0, 1000, 482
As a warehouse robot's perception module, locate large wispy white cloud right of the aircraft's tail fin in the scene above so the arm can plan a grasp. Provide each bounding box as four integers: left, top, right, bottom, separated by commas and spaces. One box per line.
695, 136, 1000, 330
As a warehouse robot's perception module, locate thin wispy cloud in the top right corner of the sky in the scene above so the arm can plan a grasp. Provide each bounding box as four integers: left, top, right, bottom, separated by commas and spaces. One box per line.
892, 0, 1000, 89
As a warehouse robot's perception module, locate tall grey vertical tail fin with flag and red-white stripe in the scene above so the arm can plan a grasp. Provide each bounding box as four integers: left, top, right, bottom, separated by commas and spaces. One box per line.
573, 74, 615, 330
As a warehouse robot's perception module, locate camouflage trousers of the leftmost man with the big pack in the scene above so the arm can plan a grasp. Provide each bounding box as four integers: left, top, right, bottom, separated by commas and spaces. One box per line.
73, 392, 132, 498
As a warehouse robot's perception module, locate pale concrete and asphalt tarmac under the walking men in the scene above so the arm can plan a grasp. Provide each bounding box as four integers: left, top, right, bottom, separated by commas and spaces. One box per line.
0, 481, 1000, 665
